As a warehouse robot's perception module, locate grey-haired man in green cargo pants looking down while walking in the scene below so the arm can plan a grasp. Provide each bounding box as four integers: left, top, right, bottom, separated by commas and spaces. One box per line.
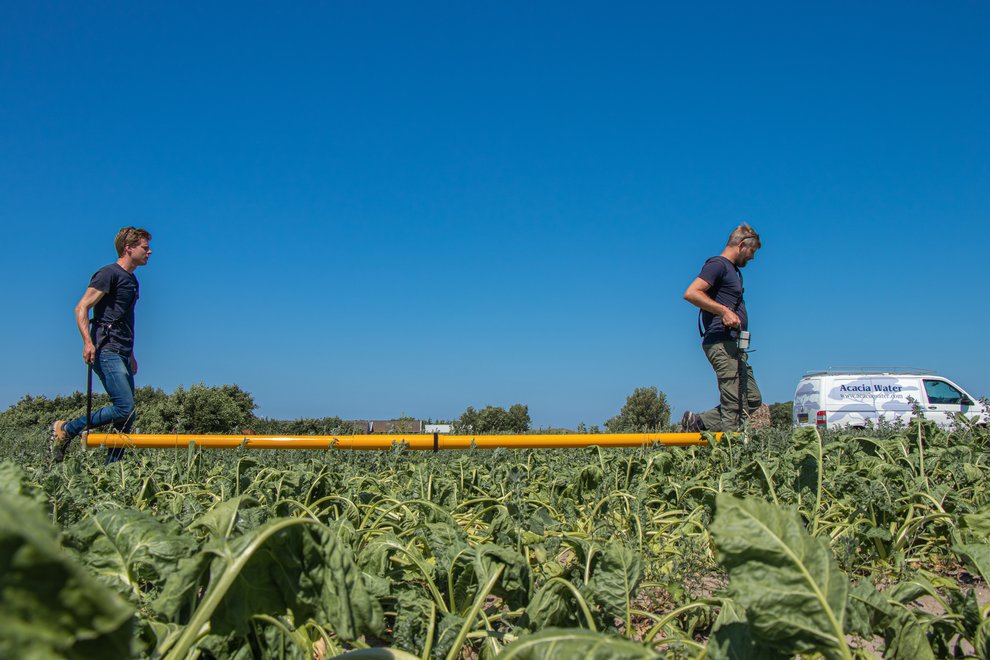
681, 223, 763, 432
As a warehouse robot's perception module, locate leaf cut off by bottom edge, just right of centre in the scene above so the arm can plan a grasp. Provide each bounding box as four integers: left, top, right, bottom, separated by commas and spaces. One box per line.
498, 628, 660, 660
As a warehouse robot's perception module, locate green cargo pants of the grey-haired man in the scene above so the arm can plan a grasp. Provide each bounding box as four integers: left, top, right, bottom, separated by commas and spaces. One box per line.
701, 341, 763, 431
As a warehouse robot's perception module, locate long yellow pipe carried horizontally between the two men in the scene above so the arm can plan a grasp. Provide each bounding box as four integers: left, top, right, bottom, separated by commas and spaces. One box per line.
82, 433, 722, 449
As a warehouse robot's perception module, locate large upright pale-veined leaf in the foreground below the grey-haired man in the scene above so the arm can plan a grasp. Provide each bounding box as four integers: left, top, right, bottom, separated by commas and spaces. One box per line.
711, 493, 849, 657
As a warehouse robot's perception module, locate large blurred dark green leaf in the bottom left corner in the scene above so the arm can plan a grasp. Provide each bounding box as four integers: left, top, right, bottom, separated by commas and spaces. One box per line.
0, 494, 135, 660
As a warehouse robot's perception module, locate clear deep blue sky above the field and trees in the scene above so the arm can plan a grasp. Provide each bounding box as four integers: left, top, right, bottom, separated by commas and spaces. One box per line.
0, 1, 990, 427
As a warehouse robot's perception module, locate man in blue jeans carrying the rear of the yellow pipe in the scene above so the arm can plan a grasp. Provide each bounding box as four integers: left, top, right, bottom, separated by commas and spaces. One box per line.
52, 227, 151, 464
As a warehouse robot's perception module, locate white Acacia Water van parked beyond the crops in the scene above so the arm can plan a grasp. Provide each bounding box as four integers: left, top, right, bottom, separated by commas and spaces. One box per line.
794, 369, 990, 429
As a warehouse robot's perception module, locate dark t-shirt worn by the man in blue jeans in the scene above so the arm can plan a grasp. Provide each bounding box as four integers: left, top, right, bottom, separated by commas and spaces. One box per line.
89, 263, 138, 356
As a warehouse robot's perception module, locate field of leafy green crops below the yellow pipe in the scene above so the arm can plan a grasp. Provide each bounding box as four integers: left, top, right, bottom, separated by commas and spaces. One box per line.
0, 420, 990, 659
